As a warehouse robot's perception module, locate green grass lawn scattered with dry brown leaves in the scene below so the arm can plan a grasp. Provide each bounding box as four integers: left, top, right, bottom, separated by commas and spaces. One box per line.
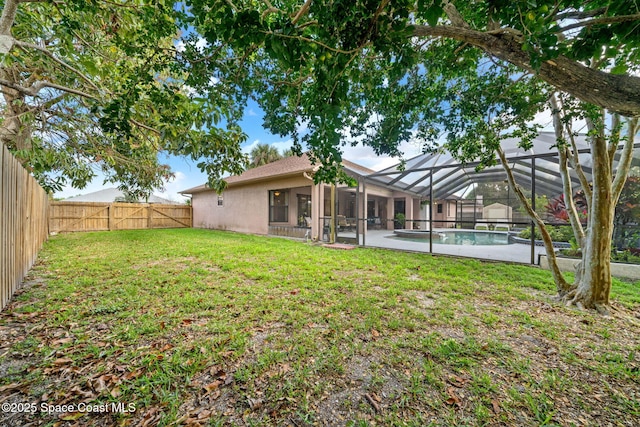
0, 229, 640, 426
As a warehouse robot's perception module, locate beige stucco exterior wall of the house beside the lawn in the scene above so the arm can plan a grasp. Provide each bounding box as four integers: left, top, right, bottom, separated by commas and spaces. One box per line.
192, 176, 312, 234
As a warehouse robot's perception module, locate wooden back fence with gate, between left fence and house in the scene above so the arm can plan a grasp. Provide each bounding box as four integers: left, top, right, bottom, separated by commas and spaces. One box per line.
49, 201, 192, 233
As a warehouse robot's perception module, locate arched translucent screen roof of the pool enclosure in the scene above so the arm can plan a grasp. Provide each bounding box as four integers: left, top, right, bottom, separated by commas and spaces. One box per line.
356, 132, 640, 263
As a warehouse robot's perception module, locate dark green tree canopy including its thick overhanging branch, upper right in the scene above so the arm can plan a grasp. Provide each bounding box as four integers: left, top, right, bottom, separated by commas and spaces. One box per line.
187, 0, 640, 178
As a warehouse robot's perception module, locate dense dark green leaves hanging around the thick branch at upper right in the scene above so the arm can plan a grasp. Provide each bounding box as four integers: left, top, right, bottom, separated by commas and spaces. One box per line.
180, 0, 638, 182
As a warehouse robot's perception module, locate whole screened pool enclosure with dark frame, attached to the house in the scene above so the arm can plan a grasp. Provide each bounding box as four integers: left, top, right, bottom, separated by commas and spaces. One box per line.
323, 132, 640, 264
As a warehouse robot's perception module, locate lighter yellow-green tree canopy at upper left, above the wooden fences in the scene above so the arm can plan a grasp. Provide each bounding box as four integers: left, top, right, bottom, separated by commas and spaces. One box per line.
0, 0, 244, 193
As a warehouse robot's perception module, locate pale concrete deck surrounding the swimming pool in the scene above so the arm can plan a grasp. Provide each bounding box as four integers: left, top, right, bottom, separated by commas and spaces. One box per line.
337, 229, 545, 264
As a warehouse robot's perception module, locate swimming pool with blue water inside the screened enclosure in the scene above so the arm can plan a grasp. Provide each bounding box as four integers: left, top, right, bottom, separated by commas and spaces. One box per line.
393, 229, 511, 246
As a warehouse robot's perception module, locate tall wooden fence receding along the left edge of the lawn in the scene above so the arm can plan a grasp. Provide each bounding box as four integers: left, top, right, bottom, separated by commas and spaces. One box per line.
0, 146, 49, 310
